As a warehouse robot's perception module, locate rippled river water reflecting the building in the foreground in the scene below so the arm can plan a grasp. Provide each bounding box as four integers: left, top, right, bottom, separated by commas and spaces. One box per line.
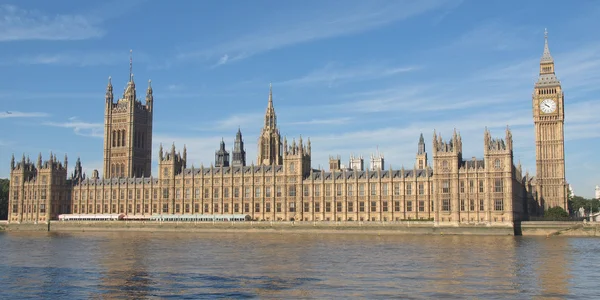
0, 232, 600, 299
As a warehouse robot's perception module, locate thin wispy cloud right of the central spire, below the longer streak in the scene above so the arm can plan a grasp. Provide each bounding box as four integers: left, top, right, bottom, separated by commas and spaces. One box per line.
277, 62, 419, 87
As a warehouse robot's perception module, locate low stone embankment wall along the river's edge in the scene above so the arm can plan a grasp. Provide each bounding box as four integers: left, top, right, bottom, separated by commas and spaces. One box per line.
0, 221, 600, 236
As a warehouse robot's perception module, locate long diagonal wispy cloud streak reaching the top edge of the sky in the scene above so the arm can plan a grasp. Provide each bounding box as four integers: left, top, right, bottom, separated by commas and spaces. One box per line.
177, 0, 452, 65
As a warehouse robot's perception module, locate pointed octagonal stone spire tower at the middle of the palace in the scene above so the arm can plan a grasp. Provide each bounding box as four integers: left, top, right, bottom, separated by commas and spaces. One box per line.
256, 85, 283, 165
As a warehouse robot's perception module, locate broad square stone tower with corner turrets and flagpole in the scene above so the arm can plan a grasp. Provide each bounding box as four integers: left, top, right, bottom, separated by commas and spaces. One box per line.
103, 50, 154, 178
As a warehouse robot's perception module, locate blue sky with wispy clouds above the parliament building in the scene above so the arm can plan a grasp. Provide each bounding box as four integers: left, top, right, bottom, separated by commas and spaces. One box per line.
0, 0, 600, 197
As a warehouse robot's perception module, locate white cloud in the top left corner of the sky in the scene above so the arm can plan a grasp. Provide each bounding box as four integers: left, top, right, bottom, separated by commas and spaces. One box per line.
0, 4, 105, 42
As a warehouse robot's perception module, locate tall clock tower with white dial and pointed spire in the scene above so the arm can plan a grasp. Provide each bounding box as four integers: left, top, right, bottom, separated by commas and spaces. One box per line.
532, 31, 567, 210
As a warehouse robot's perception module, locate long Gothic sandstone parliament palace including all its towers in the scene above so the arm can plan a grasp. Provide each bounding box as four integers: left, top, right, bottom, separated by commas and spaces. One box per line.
8, 33, 567, 226
